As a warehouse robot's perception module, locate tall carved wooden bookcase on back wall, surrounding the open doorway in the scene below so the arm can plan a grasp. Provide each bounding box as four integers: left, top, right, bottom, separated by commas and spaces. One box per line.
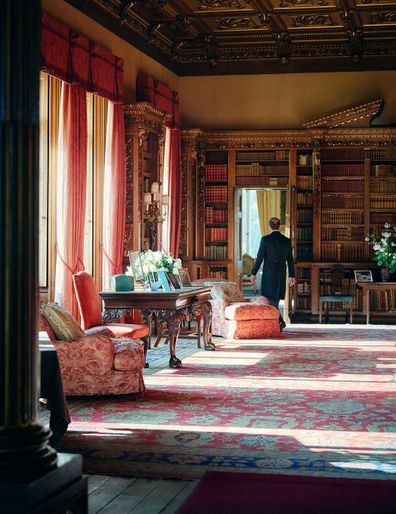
181, 101, 396, 322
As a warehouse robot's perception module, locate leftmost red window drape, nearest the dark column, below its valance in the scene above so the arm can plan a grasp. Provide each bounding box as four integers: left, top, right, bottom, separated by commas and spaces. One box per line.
55, 82, 87, 319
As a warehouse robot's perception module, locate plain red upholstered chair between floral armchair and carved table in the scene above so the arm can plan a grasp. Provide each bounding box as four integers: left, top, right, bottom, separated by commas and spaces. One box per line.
73, 271, 150, 367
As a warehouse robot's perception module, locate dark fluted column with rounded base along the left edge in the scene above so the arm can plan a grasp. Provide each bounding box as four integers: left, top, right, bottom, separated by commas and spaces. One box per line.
0, 0, 57, 482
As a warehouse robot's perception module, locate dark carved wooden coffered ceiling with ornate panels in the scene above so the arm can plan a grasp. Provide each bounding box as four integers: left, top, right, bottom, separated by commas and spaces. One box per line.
67, 0, 396, 75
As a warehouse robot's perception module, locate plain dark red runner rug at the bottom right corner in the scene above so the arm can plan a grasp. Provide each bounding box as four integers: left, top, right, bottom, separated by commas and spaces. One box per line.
177, 471, 396, 514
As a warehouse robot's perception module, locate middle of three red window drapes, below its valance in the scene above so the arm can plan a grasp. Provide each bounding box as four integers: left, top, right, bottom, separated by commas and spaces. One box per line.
102, 102, 126, 287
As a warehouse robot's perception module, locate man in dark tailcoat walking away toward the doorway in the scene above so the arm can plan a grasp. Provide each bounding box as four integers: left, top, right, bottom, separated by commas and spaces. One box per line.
251, 218, 296, 330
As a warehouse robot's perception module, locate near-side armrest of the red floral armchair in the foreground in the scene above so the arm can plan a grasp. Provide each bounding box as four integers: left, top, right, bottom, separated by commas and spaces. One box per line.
54, 335, 115, 375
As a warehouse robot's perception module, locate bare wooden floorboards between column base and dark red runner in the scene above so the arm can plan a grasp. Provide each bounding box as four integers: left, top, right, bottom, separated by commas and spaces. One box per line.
88, 475, 199, 514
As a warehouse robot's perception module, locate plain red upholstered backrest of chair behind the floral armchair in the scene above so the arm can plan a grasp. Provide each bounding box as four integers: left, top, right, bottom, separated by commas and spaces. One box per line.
73, 271, 102, 330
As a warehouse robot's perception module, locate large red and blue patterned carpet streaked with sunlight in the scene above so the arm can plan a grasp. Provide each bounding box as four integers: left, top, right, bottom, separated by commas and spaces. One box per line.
56, 325, 396, 479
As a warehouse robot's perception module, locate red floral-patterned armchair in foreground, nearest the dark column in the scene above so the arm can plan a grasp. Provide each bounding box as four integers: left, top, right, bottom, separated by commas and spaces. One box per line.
40, 313, 145, 397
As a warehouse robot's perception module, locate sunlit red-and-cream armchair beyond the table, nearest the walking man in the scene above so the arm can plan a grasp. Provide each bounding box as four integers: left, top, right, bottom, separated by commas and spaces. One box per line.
193, 278, 280, 339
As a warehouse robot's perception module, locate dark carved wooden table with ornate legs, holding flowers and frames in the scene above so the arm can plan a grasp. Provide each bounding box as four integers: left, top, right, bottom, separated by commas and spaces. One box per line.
99, 287, 215, 368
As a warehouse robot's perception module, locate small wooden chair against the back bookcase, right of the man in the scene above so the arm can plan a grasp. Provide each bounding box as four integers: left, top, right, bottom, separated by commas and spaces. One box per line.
319, 266, 355, 323
